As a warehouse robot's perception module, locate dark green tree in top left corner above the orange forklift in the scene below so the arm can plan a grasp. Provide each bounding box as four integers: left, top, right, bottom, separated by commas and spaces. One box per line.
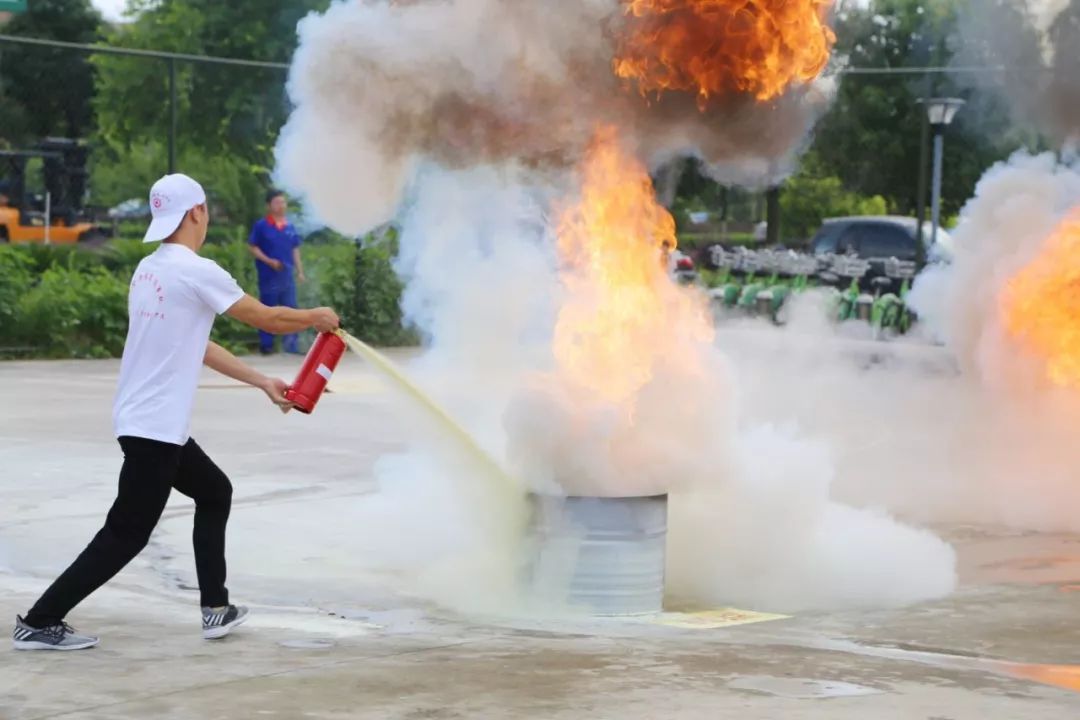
0, 0, 102, 146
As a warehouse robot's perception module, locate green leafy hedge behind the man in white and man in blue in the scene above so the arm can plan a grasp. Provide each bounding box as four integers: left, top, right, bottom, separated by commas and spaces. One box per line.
0, 227, 417, 357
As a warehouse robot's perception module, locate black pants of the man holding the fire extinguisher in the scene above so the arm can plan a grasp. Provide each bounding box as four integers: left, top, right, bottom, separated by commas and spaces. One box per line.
26, 437, 232, 627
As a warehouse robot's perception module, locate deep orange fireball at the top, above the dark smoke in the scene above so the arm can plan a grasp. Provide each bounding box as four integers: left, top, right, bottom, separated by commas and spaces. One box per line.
613, 0, 836, 111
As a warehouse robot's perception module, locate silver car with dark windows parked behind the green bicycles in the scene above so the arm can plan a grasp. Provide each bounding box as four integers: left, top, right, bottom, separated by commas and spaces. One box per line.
810, 215, 951, 291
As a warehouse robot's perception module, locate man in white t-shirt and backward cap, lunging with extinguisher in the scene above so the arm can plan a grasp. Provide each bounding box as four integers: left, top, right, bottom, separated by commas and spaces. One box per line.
13, 175, 338, 650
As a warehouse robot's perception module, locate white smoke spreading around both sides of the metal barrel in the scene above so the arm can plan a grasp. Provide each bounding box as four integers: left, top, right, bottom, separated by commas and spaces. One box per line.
334, 162, 956, 612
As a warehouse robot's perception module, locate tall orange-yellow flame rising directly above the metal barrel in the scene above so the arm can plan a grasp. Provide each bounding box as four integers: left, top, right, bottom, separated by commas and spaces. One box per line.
553, 127, 712, 403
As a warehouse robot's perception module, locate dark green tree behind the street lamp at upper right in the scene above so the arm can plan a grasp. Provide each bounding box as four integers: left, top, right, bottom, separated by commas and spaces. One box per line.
813, 0, 1014, 214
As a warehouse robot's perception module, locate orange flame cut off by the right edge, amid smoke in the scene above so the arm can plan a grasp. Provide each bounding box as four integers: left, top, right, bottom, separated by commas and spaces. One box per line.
1001, 209, 1080, 388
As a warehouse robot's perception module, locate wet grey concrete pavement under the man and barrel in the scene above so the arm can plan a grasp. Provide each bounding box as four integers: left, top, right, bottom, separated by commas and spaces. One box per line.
0, 358, 1080, 720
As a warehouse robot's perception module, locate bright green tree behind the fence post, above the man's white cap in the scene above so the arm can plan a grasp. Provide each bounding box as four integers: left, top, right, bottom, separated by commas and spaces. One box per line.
94, 0, 329, 164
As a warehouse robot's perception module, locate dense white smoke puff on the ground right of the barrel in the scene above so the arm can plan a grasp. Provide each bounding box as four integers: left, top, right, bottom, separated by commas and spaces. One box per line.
667, 425, 957, 612
